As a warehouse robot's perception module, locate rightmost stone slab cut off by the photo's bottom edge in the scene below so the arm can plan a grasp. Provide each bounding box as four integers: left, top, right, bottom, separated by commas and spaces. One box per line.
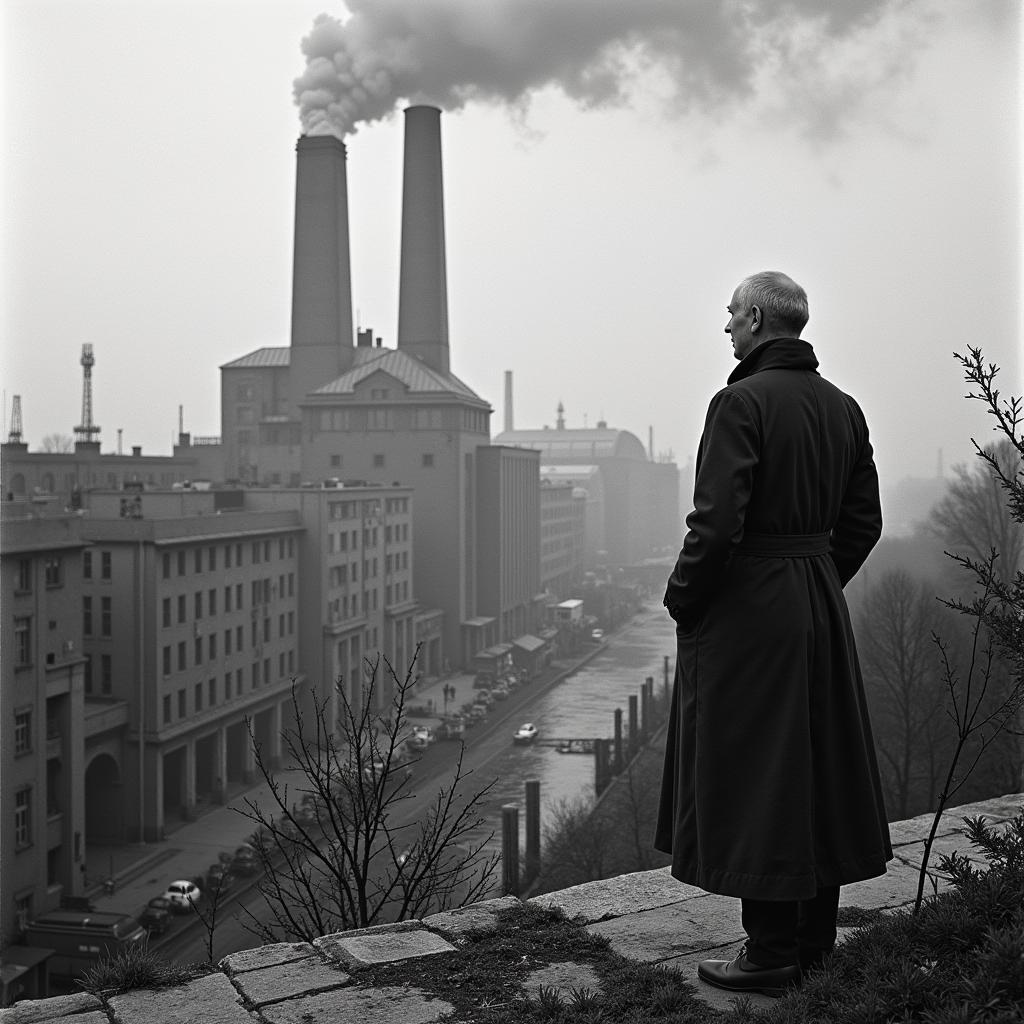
260, 986, 455, 1024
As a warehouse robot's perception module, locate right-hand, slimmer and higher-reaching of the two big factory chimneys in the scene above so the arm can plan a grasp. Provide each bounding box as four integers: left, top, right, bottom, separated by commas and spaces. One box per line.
398, 106, 449, 373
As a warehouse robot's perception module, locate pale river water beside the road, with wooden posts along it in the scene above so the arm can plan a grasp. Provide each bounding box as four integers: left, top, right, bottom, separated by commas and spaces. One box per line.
474, 607, 675, 846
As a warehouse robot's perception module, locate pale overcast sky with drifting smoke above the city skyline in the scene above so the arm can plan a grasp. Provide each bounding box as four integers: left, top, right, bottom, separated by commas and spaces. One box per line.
2, 0, 1021, 491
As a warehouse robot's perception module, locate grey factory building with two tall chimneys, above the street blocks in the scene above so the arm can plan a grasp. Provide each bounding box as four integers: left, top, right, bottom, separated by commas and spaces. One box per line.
221, 106, 542, 665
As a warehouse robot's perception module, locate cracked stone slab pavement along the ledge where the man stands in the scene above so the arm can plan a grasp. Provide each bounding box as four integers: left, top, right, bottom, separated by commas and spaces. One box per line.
8, 793, 1024, 1024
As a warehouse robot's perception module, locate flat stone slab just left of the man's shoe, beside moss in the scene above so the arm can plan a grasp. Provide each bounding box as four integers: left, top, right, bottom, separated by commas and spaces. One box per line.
587, 895, 744, 963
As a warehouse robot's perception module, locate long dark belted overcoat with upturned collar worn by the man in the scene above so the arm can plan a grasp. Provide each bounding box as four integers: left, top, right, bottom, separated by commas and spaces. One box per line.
654, 338, 892, 900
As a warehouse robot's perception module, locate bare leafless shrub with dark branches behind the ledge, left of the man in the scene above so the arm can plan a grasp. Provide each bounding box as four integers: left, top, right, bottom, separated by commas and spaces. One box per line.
240, 648, 499, 942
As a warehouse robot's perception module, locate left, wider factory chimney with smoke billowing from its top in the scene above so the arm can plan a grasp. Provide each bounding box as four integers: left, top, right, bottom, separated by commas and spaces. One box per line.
289, 135, 353, 411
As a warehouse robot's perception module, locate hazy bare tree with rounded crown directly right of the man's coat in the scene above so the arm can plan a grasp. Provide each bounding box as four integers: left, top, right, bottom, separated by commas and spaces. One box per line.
857, 569, 949, 818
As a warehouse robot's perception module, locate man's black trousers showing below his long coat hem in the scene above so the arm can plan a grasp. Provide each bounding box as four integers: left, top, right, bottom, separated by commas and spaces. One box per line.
742, 886, 839, 970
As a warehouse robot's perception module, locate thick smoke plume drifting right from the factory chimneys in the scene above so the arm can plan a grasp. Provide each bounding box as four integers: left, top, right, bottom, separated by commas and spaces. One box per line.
294, 0, 932, 136
